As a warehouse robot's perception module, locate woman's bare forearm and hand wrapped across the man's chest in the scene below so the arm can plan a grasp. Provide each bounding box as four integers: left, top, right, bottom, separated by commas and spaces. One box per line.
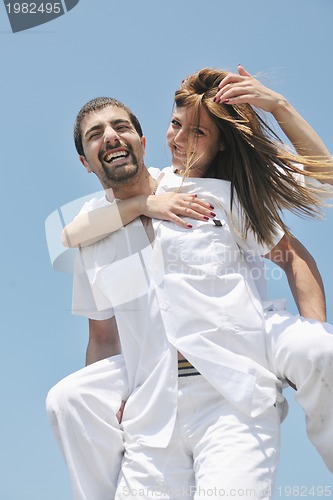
61, 193, 215, 248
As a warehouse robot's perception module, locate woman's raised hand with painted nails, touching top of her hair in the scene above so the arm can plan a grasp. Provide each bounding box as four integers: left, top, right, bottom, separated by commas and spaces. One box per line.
215, 65, 286, 115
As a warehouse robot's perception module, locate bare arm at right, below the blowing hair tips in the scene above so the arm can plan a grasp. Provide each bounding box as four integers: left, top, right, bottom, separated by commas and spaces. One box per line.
265, 235, 326, 321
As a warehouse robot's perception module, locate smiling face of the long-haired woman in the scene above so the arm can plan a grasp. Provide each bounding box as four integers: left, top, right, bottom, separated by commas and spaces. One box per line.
167, 107, 224, 177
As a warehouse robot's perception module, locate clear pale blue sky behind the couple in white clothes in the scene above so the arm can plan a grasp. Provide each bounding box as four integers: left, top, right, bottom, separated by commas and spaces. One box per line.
0, 0, 333, 500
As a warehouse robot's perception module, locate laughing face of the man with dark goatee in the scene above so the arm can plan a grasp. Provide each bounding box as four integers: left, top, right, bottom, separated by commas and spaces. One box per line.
80, 106, 145, 189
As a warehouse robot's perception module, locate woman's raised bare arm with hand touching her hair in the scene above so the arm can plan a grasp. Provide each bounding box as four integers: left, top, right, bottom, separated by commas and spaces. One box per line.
216, 65, 333, 184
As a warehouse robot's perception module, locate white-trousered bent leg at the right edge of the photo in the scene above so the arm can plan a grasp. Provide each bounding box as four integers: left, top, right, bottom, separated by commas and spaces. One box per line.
266, 311, 333, 472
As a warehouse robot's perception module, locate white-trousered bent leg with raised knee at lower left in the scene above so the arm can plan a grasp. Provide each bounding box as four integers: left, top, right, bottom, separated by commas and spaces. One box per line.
46, 356, 128, 500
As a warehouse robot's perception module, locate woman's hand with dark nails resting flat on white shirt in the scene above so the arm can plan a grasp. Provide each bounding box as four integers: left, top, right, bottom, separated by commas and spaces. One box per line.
142, 193, 215, 228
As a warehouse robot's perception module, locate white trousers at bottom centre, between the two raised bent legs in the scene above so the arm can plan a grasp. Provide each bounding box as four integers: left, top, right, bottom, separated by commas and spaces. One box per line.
116, 375, 281, 500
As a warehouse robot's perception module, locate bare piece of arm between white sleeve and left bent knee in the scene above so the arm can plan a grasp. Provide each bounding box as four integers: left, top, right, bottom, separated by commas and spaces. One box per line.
86, 316, 121, 365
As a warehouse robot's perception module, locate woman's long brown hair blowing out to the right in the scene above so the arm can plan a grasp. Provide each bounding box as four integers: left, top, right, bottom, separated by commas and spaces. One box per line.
175, 68, 332, 245
